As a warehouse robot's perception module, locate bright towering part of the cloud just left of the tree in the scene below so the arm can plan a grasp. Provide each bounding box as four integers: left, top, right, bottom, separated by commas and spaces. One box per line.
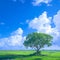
9, 28, 23, 46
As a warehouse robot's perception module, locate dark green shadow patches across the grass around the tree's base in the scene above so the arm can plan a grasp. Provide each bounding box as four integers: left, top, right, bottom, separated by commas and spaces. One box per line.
0, 53, 44, 60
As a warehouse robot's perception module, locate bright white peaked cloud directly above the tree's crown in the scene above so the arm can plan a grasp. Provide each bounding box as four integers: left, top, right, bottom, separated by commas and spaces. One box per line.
29, 12, 52, 33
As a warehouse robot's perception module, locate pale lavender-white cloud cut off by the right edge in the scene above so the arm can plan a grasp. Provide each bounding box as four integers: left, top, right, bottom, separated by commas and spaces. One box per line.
53, 10, 60, 46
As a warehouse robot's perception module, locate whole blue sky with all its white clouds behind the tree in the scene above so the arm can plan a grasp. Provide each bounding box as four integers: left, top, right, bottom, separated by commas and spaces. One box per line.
0, 0, 60, 50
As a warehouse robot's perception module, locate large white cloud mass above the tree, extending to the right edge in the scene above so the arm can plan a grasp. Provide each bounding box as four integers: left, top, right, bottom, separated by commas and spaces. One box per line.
29, 11, 60, 49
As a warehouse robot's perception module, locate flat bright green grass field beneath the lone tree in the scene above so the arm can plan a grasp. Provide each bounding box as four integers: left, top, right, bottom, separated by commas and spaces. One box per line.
0, 51, 60, 60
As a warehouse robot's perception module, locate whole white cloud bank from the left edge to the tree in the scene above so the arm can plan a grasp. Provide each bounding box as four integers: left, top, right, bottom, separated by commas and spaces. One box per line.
0, 28, 24, 49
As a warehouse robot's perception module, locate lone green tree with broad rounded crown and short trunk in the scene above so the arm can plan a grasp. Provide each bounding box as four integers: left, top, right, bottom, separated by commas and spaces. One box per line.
24, 32, 53, 55
